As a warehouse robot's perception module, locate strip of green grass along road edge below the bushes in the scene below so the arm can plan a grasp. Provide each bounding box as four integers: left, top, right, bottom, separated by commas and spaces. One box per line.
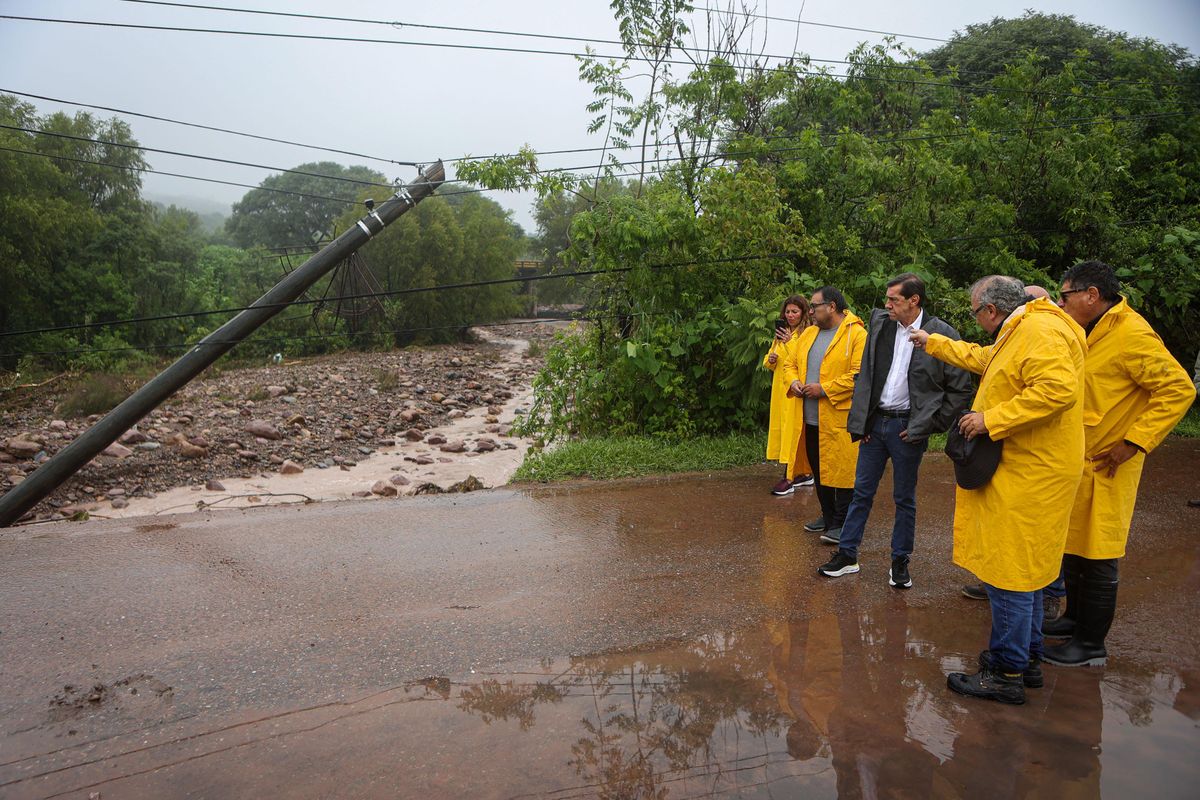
512, 433, 767, 483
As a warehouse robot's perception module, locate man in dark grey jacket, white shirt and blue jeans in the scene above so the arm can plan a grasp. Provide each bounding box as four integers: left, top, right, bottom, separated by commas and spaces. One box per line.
817, 272, 974, 589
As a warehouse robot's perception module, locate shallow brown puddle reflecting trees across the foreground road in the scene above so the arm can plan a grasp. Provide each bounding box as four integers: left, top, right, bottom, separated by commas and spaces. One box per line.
23, 618, 1200, 799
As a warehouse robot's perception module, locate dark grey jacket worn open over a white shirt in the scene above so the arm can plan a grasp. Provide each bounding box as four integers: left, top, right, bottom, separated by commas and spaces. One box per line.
846, 308, 974, 441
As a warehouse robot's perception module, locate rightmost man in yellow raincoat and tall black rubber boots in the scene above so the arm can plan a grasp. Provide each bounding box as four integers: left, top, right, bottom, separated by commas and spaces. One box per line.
1043, 261, 1195, 667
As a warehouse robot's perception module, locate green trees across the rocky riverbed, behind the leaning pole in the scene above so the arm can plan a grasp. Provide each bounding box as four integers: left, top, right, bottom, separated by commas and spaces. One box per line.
0, 95, 527, 369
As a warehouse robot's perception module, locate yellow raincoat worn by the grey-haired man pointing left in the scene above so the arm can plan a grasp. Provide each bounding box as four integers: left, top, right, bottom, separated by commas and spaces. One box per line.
925, 299, 1086, 591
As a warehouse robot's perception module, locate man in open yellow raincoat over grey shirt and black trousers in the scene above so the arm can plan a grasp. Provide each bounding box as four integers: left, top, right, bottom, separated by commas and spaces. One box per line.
782, 287, 866, 544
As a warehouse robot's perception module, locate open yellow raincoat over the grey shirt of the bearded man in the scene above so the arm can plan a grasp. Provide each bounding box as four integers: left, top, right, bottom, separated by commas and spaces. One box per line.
775, 312, 866, 489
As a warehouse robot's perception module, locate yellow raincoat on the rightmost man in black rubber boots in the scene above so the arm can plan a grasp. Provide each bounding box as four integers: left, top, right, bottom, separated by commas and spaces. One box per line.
1067, 300, 1196, 559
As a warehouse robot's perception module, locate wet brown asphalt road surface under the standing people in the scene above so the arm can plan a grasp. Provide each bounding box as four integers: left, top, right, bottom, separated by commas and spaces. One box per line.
0, 440, 1200, 799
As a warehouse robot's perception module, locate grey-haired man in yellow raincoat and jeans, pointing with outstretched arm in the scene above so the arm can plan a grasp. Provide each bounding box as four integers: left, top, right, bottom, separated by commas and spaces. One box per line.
913, 275, 1086, 704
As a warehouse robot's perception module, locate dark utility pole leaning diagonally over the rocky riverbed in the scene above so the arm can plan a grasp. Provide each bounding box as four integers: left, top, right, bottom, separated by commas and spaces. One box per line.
0, 161, 445, 528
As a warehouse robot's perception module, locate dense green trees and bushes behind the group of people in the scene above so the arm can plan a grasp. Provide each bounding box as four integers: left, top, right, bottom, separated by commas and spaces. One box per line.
458, 9, 1200, 437
